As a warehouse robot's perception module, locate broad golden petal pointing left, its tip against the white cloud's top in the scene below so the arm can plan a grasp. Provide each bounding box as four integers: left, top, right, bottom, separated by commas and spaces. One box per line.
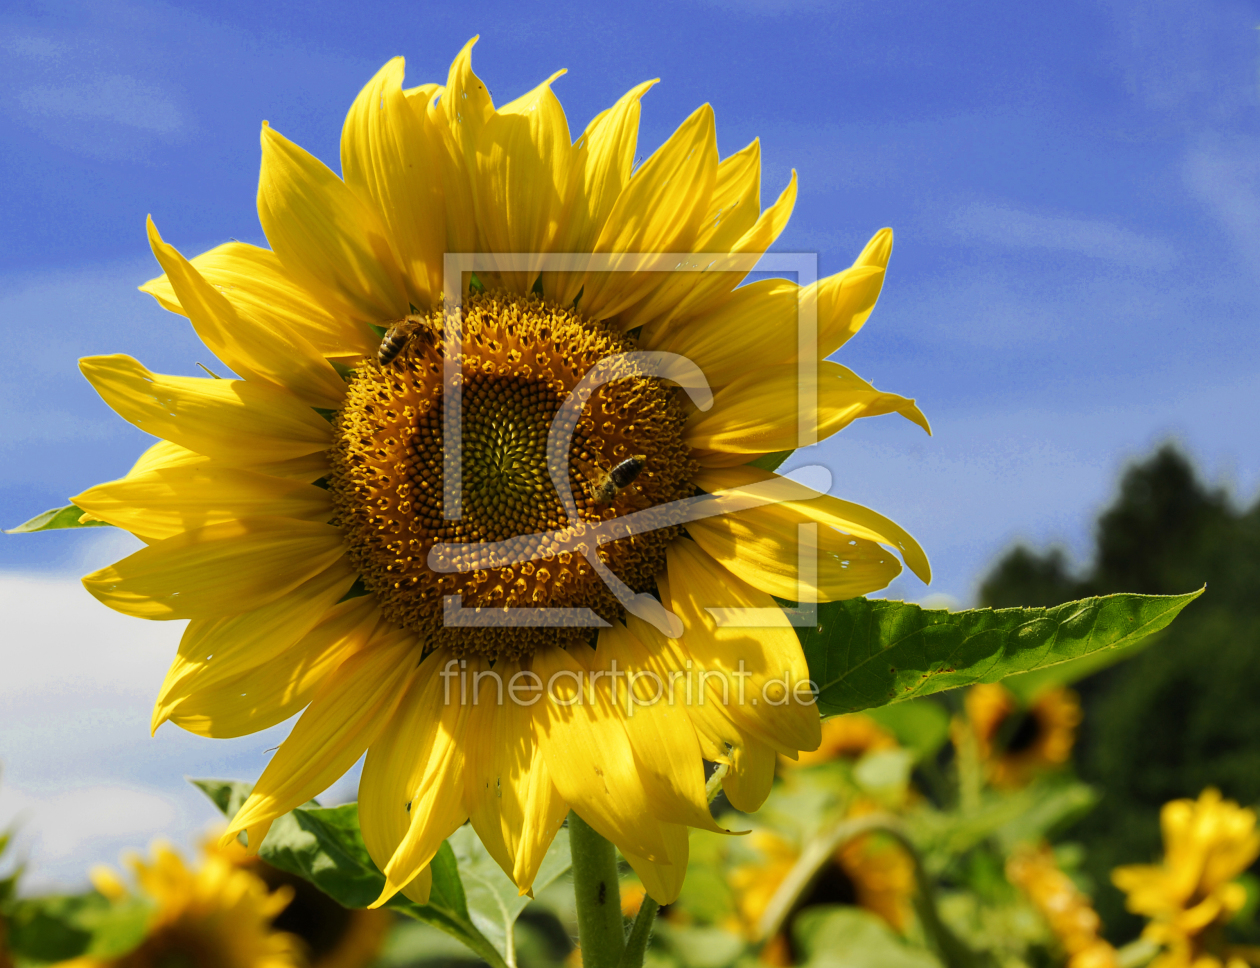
83, 518, 345, 619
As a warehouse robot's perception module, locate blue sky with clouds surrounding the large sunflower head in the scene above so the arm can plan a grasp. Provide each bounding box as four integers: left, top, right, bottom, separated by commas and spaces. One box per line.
0, 0, 1260, 881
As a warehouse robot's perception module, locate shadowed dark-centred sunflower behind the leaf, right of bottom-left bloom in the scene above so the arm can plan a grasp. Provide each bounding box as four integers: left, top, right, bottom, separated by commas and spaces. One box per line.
203, 838, 394, 968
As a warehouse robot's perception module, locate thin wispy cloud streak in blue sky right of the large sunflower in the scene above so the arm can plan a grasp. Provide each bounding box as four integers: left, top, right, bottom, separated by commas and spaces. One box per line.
951, 203, 1177, 268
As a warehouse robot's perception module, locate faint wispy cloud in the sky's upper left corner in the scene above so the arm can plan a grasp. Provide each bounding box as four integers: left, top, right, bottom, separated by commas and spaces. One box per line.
16, 74, 186, 135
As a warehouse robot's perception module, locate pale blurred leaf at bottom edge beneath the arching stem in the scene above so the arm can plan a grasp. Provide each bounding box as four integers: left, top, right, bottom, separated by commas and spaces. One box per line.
793, 906, 940, 968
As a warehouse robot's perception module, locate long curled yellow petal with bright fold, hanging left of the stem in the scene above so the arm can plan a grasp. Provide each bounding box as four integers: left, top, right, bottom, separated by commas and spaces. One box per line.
359, 649, 470, 905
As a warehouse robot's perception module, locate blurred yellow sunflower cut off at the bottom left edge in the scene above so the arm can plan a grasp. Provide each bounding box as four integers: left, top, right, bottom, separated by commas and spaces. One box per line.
63, 842, 305, 968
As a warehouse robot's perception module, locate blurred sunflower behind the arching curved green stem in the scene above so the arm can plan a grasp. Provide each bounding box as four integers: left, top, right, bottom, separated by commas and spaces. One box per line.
731, 826, 915, 964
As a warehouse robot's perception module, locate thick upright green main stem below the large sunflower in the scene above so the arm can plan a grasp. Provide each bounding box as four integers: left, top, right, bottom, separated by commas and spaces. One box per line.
568, 810, 622, 968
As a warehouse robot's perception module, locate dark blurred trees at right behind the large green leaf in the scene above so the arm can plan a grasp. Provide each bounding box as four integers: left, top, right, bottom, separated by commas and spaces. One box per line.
980, 447, 1260, 942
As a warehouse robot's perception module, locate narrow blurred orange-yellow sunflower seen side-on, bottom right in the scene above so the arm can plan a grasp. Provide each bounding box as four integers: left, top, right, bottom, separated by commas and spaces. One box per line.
1007, 844, 1119, 968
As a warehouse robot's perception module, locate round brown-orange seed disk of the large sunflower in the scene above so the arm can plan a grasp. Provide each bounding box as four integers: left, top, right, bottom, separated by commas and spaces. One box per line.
329, 292, 696, 657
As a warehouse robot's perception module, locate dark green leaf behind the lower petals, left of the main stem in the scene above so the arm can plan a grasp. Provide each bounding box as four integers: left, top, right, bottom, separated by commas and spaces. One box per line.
193, 780, 505, 968
